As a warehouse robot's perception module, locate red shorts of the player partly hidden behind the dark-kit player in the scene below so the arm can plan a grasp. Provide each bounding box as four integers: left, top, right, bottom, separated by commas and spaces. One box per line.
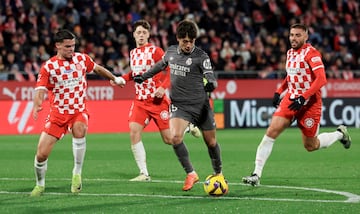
129, 98, 170, 130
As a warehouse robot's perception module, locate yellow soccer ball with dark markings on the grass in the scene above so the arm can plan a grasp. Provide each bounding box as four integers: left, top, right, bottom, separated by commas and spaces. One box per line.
204, 175, 229, 196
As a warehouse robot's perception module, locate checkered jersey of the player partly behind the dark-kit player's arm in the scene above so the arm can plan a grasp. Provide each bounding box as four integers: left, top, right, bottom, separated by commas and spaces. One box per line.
128, 43, 170, 100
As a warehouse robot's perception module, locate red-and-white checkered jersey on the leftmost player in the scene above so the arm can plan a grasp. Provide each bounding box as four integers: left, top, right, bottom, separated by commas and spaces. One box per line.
35, 53, 96, 114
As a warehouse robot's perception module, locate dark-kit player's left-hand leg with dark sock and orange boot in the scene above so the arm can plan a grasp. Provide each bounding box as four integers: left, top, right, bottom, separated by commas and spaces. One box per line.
170, 117, 199, 191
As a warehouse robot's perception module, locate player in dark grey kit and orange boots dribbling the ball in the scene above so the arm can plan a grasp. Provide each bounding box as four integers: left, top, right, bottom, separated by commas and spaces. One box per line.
134, 20, 222, 191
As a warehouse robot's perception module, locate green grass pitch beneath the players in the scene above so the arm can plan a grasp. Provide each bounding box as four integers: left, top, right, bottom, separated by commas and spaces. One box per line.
0, 128, 360, 214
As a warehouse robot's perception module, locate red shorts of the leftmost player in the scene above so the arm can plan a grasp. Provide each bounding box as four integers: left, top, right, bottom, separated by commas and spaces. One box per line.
43, 111, 89, 139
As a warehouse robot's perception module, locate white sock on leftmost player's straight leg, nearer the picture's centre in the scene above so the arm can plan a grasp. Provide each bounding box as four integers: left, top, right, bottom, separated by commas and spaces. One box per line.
72, 137, 86, 175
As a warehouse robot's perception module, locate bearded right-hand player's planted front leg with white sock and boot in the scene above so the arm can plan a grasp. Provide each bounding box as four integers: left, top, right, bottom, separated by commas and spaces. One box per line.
242, 116, 291, 186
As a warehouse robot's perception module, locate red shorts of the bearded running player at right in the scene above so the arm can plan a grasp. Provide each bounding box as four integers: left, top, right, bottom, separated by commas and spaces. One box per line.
274, 94, 322, 137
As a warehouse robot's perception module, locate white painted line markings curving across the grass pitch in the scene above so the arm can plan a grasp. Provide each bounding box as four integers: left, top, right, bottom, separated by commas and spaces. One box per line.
0, 178, 360, 203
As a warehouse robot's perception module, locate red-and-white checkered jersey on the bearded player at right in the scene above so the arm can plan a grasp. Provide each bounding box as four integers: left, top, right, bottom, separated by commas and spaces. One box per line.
286, 43, 325, 99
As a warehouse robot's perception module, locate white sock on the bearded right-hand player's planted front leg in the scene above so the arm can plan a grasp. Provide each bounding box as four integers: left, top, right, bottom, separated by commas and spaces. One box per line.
254, 135, 275, 177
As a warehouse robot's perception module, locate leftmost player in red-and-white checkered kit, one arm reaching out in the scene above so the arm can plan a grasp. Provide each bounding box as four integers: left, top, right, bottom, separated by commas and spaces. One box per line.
30, 30, 125, 196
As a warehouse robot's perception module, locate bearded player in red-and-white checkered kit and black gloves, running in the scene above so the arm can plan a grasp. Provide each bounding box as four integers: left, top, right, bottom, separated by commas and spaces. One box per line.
242, 23, 351, 186
